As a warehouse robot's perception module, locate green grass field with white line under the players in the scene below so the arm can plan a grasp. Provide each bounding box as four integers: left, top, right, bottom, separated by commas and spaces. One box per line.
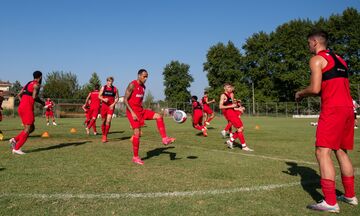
0, 117, 360, 215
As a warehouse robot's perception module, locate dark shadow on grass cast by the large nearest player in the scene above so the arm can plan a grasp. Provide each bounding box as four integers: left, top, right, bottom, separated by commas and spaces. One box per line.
282, 162, 341, 201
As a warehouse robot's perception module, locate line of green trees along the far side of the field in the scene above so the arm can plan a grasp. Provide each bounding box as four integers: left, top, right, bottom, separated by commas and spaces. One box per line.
12, 8, 360, 103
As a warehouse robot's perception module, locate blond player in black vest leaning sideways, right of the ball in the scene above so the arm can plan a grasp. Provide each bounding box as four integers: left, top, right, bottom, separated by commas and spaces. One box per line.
219, 83, 253, 151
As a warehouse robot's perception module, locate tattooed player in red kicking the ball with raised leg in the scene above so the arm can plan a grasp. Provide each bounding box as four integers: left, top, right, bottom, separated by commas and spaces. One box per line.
124, 69, 175, 165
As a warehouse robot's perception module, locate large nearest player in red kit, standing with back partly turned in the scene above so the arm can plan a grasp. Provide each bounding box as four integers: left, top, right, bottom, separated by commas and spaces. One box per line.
295, 30, 358, 212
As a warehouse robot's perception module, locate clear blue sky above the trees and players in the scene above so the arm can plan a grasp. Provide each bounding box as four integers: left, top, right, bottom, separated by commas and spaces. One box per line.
0, 0, 360, 100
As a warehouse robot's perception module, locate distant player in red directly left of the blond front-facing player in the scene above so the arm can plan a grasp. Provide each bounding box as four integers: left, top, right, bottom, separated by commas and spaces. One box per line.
84, 84, 100, 135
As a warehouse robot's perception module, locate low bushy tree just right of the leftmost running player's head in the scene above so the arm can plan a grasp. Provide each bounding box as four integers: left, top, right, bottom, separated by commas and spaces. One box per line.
43, 71, 80, 99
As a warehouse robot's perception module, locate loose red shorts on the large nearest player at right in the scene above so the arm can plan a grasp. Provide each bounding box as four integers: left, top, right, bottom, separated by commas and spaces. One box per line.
315, 107, 354, 150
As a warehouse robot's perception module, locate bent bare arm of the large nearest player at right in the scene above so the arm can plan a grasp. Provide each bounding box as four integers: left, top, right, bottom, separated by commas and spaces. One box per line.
295, 56, 327, 101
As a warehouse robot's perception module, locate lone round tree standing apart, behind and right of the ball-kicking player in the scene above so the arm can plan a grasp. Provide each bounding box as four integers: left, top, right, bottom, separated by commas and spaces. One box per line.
163, 61, 194, 102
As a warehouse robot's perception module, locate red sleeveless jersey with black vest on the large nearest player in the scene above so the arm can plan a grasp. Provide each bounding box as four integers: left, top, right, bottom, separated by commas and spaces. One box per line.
318, 50, 352, 107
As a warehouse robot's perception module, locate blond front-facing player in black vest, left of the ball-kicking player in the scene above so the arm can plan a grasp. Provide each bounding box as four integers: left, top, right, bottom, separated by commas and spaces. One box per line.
99, 77, 119, 143
